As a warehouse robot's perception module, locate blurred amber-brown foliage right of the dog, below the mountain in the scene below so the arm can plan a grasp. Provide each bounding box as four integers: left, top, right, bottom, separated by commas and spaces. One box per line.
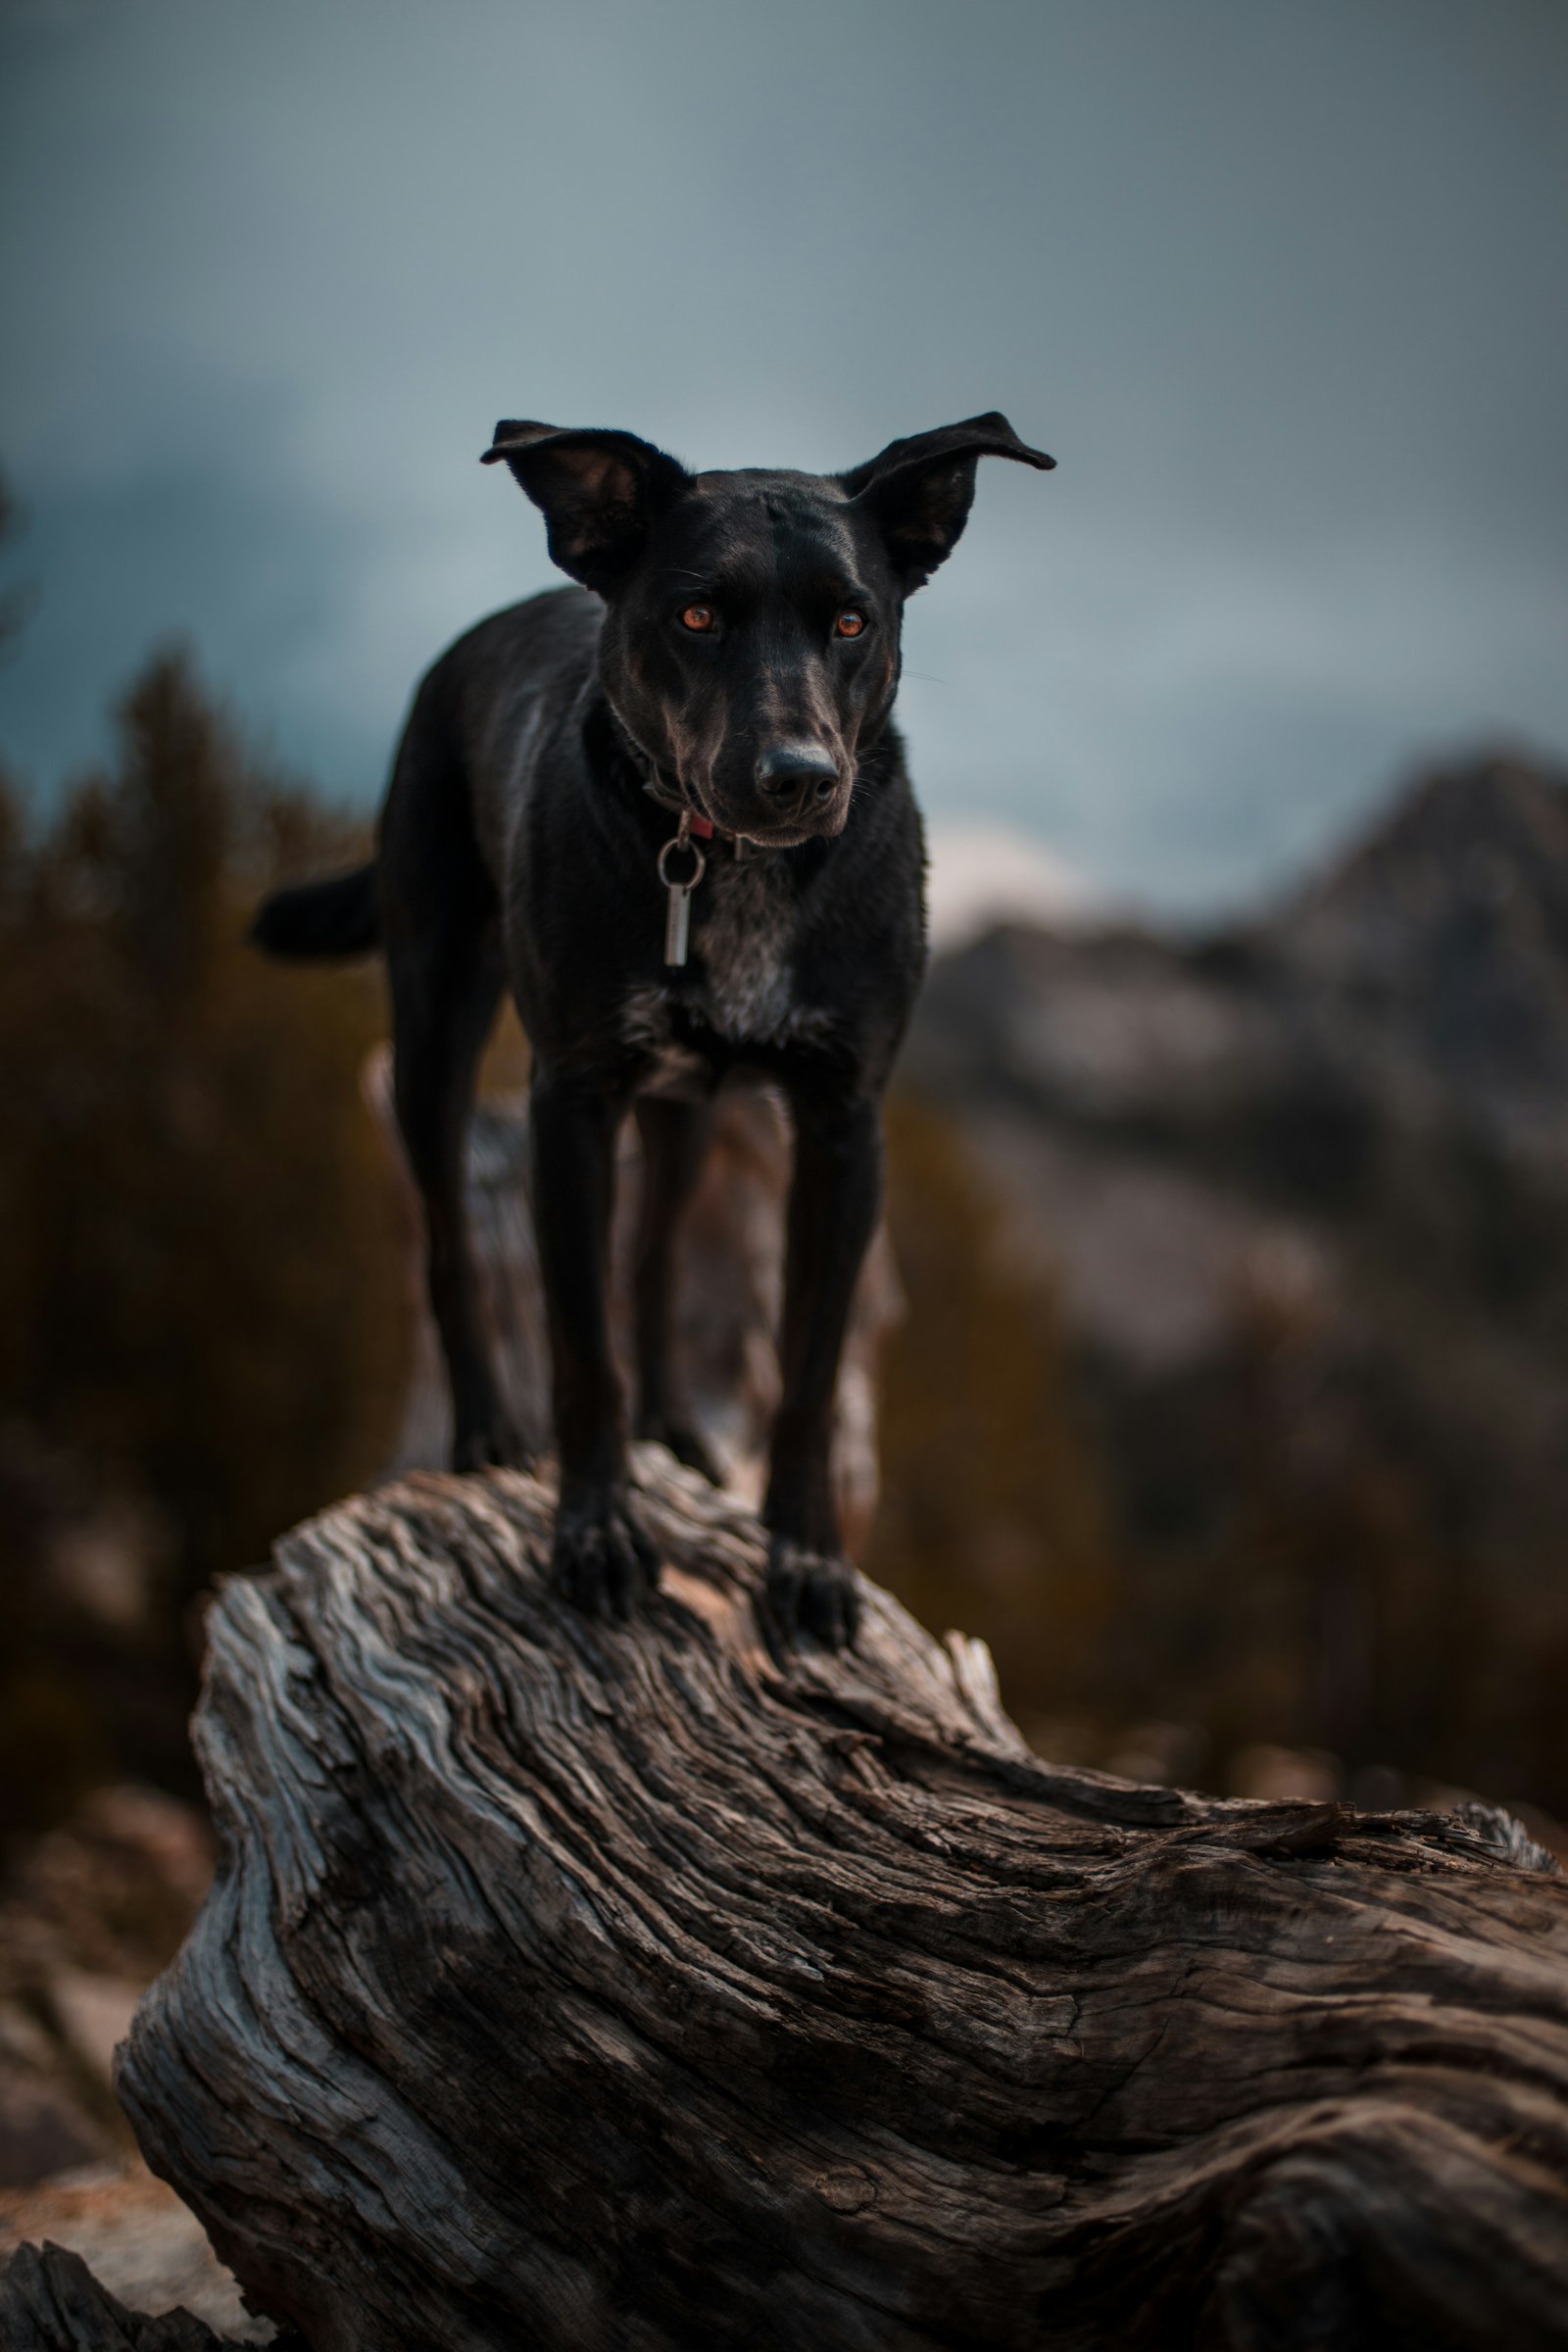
865, 1094, 1568, 1813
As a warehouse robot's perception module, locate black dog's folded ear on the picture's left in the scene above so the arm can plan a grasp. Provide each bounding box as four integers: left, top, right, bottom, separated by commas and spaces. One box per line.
479, 416, 691, 595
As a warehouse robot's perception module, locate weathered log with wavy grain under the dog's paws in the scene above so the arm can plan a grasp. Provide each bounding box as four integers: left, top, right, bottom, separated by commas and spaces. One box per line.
101, 1448, 1568, 2352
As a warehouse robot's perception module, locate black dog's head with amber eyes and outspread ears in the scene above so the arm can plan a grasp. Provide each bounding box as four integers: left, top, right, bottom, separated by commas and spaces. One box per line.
484, 414, 1055, 849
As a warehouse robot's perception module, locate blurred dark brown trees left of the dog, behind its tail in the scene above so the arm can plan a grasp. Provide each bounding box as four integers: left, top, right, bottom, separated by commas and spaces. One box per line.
0, 654, 409, 1818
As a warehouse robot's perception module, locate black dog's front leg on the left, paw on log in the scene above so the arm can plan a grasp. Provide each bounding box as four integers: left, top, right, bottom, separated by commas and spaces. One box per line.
529, 1075, 659, 1616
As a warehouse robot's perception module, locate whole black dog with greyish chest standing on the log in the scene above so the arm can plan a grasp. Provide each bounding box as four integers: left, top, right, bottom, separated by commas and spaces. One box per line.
256, 414, 1054, 1644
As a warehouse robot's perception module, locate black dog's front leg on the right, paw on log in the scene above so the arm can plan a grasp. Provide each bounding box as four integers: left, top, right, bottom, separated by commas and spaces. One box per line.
764, 1092, 882, 1648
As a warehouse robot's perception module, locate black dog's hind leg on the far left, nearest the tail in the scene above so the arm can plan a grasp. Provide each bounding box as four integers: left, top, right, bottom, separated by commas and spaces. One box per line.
388, 899, 526, 1470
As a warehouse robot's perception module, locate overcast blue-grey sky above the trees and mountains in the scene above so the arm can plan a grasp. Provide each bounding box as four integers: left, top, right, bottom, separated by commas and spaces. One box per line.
0, 0, 1568, 907
